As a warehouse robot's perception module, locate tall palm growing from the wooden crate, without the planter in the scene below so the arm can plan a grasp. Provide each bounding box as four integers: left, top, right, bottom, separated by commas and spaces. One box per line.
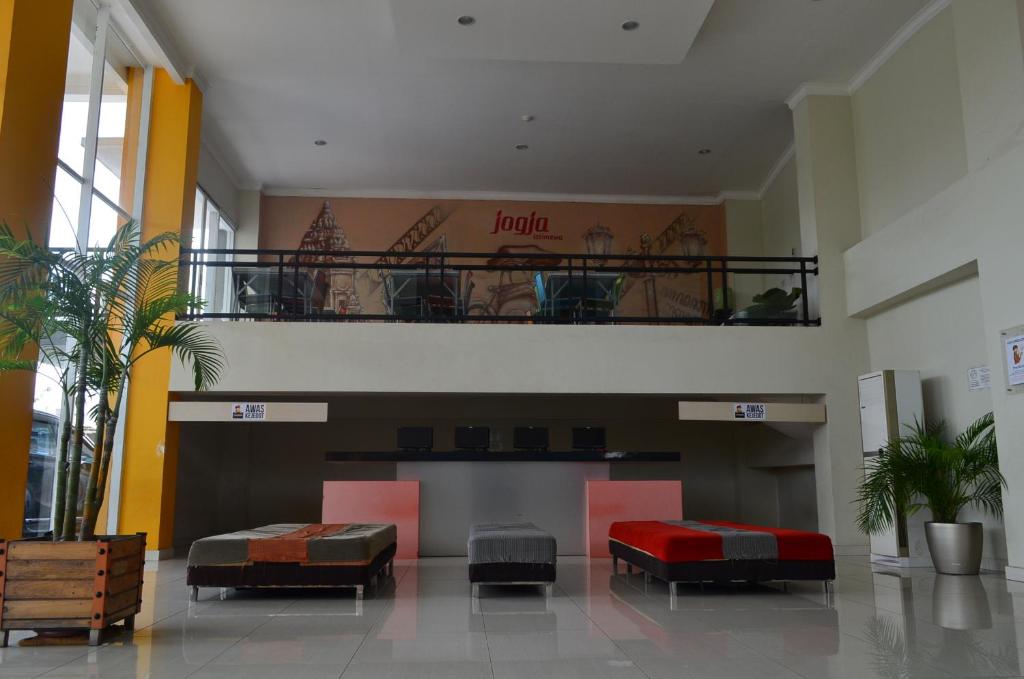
0, 222, 224, 540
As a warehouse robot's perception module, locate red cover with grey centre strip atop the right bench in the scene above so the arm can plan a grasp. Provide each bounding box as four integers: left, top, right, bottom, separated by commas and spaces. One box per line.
608, 521, 834, 563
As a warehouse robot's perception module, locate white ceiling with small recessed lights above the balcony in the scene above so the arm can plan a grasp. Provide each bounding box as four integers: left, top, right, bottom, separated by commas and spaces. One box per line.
136, 0, 928, 196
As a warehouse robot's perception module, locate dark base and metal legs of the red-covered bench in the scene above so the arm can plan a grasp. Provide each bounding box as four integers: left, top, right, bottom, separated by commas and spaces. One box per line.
608, 540, 836, 597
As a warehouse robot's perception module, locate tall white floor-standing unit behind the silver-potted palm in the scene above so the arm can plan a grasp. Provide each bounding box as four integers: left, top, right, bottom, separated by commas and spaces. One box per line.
857, 370, 927, 565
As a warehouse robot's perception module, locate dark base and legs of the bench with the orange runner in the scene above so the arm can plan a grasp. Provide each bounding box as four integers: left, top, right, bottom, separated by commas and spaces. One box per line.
185, 543, 397, 601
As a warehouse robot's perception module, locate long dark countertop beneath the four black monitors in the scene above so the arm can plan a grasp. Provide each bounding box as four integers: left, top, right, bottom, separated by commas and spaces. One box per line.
325, 451, 679, 462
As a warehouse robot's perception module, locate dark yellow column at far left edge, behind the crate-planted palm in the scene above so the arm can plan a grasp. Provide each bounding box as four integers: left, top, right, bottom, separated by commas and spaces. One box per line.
0, 0, 72, 538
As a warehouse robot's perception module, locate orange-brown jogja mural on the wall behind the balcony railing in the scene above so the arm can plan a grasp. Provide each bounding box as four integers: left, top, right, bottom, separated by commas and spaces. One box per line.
260, 197, 725, 316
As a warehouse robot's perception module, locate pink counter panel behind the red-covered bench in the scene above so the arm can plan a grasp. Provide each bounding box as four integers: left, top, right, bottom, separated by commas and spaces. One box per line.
586, 480, 683, 558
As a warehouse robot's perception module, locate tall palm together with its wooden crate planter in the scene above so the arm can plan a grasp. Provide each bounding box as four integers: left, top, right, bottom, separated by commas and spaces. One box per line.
0, 222, 223, 645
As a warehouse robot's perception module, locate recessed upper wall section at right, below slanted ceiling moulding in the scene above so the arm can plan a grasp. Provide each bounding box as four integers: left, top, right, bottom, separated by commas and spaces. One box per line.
852, 3, 966, 237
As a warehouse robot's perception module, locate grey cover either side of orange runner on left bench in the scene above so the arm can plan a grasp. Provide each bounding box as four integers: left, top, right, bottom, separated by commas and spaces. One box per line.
188, 523, 398, 566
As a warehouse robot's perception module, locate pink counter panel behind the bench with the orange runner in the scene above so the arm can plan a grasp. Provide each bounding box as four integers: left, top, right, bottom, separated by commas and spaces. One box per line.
322, 481, 420, 559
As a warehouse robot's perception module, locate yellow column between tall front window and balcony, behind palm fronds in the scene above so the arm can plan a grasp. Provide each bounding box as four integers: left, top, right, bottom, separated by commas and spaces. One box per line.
118, 71, 203, 552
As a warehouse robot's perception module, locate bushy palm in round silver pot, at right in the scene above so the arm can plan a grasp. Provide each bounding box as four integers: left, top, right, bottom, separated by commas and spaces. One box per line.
857, 413, 1007, 576
